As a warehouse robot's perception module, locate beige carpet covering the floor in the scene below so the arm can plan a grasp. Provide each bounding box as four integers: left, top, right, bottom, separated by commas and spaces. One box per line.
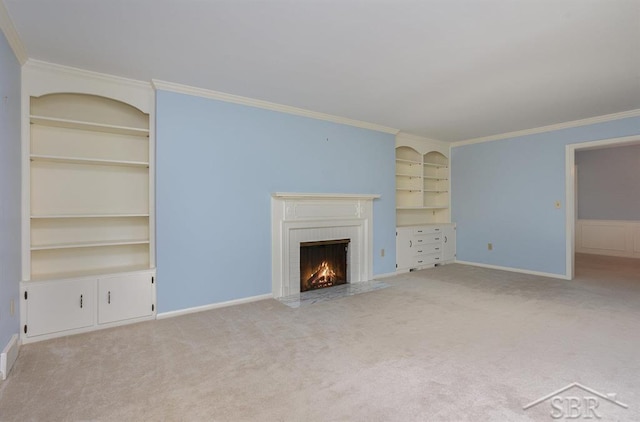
0, 256, 640, 421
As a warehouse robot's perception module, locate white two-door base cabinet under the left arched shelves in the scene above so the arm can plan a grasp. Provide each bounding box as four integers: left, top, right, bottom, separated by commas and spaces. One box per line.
20, 271, 156, 342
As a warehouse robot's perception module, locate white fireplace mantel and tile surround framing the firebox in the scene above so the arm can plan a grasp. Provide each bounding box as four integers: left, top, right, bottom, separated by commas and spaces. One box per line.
271, 192, 380, 298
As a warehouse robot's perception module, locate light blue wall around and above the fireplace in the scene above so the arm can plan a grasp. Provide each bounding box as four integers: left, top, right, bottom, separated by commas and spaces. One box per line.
156, 91, 395, 312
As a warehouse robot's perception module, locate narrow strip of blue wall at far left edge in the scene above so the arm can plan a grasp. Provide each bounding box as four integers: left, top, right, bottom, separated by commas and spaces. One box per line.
0, 32, 21, 350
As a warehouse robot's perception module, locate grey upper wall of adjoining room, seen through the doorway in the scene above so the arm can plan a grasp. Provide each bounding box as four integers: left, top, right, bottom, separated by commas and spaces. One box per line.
576, 145, 640, 221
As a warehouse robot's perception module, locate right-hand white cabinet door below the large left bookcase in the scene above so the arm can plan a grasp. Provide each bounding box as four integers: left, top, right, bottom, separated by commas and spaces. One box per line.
98, 273, 153, 324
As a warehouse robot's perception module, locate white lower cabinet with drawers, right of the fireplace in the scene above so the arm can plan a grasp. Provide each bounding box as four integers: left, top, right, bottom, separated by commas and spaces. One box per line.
396, 224, 455, 271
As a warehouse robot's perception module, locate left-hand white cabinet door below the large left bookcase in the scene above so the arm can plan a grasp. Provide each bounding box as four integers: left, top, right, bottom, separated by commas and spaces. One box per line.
22, 279, 96, 337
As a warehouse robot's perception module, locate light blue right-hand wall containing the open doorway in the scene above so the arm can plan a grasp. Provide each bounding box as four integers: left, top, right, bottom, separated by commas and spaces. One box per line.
451, 118, 640, 275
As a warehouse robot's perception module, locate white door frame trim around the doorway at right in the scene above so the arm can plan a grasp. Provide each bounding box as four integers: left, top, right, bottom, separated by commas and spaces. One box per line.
565, 135, 640, 280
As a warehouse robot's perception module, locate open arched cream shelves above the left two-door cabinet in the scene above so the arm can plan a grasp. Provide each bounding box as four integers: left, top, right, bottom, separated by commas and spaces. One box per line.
29, 94, 150, 279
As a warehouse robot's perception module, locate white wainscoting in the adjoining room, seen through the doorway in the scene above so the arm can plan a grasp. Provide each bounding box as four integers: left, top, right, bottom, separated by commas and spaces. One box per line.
576, 220, 640, 258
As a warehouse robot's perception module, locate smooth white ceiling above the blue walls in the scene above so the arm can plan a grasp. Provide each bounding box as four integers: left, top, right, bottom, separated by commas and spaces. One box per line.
5, 0, 640, 141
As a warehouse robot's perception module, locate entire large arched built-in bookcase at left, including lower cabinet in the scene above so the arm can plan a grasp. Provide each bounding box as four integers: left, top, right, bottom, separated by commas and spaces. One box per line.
21, 62, 156, 342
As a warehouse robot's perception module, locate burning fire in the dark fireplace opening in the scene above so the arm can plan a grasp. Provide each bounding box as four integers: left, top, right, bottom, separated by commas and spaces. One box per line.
300, 239, 349, 292
